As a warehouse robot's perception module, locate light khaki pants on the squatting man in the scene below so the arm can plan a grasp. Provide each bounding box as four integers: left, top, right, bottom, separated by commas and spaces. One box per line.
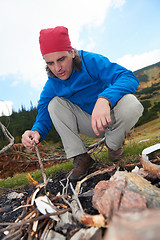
48, 94, 143, 158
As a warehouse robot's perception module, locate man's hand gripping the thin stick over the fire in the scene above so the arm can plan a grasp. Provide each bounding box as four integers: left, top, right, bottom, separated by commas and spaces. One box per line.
22, 130, 41, 148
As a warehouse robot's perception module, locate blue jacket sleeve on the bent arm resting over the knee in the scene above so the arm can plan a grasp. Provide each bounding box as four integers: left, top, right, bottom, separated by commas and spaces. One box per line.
82, 51, 139, 107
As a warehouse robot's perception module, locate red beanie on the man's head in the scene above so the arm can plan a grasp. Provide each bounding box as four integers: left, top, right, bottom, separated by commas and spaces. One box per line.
39, 26, 72, 56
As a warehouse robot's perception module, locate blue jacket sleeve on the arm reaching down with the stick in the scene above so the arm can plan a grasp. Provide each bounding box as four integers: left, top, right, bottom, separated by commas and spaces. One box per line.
31, 80, 55, 141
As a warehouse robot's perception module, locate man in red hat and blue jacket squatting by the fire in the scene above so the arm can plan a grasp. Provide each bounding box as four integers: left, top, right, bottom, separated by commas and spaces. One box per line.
22, 26, 143, 180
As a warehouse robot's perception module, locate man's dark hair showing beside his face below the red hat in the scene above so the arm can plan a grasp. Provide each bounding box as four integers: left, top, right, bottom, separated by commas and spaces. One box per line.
46, 49, 82, 78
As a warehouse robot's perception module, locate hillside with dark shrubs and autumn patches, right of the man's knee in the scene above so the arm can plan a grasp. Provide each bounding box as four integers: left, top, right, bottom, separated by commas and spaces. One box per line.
134, 62, 160, 126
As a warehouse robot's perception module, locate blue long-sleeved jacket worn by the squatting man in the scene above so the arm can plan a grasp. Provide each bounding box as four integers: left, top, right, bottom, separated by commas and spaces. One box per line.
32, 50, 139, 141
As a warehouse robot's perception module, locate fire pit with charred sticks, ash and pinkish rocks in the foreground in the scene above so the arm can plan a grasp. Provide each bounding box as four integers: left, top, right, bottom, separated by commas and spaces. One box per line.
0, 145, 160, 240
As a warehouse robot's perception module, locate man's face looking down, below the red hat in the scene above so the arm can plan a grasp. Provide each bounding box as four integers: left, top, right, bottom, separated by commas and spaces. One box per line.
43, 50, 75, 80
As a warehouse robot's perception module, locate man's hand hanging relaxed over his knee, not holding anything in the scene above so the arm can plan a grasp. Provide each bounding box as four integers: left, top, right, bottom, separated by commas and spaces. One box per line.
92, 98, 111, 136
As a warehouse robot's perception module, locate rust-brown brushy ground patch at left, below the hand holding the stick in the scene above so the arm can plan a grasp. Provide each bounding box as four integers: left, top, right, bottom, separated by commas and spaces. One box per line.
0, 143, 66, 179
